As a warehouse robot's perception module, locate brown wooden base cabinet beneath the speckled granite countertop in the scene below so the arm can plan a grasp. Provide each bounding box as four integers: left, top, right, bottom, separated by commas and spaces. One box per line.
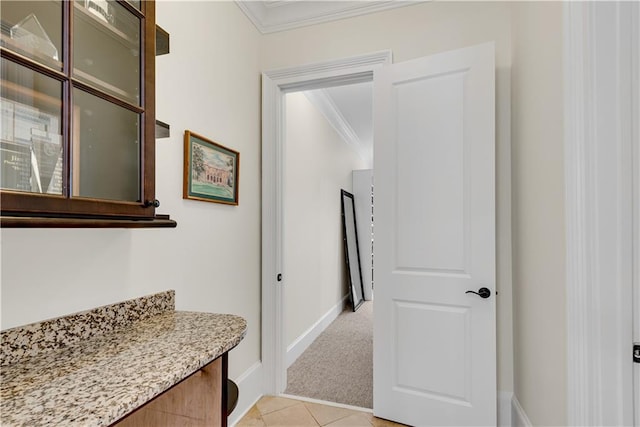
113, 353, 227, 427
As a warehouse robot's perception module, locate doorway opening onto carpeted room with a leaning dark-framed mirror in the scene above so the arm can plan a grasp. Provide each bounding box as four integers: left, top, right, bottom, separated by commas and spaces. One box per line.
282, 82, 373, 409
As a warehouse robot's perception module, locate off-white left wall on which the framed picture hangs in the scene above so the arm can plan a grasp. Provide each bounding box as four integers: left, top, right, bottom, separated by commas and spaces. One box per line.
1, 1, 260, 378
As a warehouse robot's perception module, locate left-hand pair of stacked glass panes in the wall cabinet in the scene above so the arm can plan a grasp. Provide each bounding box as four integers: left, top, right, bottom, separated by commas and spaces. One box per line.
0, 0, 63, 195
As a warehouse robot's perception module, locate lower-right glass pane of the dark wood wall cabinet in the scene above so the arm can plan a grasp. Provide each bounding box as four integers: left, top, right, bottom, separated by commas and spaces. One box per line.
72, 89, 141, 202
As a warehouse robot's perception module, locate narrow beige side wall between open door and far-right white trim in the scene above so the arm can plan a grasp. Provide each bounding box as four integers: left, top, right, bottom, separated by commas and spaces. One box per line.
512, 2, 567, 425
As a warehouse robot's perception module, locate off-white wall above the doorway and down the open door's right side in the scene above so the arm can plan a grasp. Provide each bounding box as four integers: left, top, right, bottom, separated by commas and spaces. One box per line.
261, 2, 513, 391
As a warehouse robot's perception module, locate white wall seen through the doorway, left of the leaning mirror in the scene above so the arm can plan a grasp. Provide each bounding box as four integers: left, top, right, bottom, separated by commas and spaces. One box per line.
283, 92, 365, 346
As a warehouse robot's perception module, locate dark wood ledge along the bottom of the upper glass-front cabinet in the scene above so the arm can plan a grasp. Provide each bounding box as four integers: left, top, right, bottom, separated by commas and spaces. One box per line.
0, 215, 178, 228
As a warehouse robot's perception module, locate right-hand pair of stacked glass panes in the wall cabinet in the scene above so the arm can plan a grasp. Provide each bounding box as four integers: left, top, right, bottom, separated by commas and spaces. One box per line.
71, 0, 141, 202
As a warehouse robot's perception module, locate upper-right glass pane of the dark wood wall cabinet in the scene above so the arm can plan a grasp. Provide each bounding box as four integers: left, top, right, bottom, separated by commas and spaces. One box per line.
73, 0, 141, 105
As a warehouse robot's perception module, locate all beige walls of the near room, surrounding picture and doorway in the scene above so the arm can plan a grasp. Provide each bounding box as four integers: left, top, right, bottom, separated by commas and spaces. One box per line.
0, 1, 566, 425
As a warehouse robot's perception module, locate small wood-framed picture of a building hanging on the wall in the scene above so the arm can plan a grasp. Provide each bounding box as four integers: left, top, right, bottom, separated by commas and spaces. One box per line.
182, 130, 240, 205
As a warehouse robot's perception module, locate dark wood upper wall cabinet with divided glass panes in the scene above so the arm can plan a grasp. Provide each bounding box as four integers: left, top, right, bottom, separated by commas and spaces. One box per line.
0, 0, 175, 226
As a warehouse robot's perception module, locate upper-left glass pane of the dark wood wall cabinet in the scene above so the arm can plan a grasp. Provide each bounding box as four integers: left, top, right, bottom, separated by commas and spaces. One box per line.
0, 0, 63, 70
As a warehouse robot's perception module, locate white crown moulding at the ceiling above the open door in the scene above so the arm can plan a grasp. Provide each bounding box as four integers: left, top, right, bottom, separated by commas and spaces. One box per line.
236, 0, 424, 34
